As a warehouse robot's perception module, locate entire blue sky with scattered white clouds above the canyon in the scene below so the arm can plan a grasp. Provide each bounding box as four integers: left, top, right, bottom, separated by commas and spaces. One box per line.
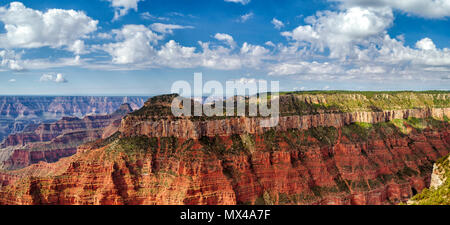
0, 0, 450, 95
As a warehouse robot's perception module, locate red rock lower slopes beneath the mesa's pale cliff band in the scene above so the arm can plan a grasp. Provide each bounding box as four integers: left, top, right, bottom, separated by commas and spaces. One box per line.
0, 116, 450, 204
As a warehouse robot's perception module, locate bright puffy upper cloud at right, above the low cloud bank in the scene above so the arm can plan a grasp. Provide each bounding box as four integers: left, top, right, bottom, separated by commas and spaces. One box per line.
282, 7, 393, 58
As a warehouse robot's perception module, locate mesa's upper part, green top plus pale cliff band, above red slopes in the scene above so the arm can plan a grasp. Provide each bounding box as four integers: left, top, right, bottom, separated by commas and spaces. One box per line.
119, 92, 450, 139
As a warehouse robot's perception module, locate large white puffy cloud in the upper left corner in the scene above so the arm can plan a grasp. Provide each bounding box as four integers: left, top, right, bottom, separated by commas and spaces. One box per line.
0, 2, 98, 54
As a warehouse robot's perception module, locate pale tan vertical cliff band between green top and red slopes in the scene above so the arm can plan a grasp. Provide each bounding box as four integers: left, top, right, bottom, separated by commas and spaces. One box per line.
119, 108, 450, 139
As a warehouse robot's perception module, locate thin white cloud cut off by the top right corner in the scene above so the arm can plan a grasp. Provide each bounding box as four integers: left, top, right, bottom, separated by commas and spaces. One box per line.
332, 0, 450, 18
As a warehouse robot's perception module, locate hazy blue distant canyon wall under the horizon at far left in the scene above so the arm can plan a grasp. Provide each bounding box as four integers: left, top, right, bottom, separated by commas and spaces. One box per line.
0, 96, 146, 140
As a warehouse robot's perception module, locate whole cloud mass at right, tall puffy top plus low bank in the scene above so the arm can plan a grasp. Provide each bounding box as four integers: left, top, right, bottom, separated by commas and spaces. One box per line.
268, 5, 450, 81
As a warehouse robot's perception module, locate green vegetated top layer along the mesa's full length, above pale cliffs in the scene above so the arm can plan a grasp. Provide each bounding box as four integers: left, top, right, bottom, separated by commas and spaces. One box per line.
127, 91, 450, 119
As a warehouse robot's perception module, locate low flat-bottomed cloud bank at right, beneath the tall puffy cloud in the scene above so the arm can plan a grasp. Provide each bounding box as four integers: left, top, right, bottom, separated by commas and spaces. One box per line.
269, 32, 450, 81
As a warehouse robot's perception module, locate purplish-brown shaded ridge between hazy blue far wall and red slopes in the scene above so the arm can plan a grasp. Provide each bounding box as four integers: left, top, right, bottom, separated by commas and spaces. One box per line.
0, 104, 132, 170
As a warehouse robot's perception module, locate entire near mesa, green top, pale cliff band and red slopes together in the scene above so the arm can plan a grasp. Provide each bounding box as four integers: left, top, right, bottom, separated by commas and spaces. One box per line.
0, 92, 450, 204
